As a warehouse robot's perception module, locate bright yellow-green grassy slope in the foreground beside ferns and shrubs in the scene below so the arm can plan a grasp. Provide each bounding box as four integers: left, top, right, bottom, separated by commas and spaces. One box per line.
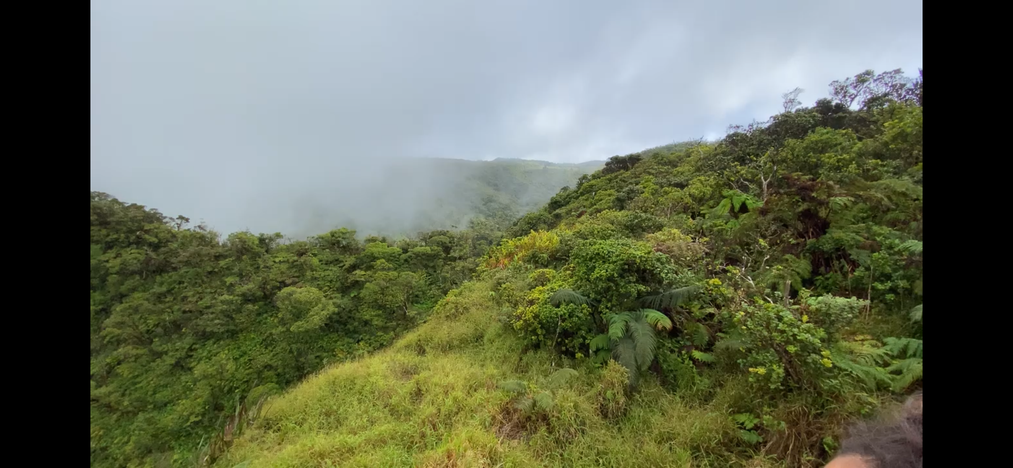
216, 282, 745, 468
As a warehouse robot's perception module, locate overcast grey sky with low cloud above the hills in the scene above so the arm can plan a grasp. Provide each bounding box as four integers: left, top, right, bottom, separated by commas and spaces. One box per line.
91, 0, 922, 238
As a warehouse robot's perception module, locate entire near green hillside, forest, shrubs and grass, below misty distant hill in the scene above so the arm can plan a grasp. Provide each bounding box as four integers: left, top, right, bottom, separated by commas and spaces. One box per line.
91, 66, 922, 468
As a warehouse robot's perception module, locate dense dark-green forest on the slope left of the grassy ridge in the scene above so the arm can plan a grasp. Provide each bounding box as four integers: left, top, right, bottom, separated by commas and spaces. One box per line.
90, 192, 500, 466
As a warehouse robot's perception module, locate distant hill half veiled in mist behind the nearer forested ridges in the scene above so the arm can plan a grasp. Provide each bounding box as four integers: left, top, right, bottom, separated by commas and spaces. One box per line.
279, 158, 604, 238
